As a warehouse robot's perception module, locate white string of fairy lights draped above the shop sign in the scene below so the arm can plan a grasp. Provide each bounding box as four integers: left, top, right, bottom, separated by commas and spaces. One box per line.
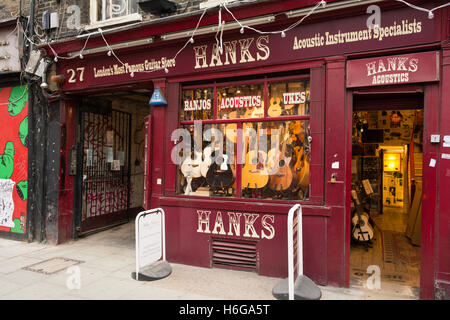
20, 0, 450, 81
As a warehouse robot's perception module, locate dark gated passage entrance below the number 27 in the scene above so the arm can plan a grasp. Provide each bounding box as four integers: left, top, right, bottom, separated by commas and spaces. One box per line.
75, 93, 150, 235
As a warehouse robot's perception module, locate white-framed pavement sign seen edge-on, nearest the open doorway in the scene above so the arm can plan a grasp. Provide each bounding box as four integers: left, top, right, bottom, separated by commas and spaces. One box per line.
272, 204, 322, 300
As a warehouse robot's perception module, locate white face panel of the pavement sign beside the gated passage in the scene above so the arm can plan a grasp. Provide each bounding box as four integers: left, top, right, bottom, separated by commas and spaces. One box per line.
136, 211, 163, 268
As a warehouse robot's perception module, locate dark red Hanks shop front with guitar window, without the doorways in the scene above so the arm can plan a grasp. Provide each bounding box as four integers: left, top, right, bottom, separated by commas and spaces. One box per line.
47, 1, 450, 298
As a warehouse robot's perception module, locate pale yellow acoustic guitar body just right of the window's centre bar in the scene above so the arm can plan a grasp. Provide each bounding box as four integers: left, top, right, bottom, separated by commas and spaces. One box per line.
242, 150, 269, 189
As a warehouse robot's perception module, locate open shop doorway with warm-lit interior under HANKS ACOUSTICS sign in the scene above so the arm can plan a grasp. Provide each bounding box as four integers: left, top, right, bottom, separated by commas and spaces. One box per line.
350, 95, 424, 295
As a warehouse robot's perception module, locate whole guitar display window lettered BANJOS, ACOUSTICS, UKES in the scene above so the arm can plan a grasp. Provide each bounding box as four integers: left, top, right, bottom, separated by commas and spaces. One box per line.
176, 78, 310, 200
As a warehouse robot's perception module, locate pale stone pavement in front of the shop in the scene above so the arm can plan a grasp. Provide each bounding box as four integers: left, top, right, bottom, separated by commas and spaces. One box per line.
0, 222, 418, 300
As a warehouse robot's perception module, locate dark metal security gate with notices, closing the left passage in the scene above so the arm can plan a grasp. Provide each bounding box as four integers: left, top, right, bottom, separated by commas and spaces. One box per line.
75, 108, 131, 235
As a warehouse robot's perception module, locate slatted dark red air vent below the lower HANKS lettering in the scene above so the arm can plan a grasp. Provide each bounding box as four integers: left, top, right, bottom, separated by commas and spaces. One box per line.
211, 238, 258, 272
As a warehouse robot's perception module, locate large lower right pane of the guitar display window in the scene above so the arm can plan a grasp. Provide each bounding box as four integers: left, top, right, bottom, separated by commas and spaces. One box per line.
241, 120, 309, 200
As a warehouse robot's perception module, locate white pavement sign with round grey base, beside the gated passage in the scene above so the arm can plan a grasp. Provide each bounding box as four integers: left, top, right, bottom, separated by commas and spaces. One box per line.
131, 208, 172, 281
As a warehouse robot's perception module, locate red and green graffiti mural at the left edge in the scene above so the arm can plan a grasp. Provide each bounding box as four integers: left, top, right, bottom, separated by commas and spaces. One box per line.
0, 86, 28, 233
